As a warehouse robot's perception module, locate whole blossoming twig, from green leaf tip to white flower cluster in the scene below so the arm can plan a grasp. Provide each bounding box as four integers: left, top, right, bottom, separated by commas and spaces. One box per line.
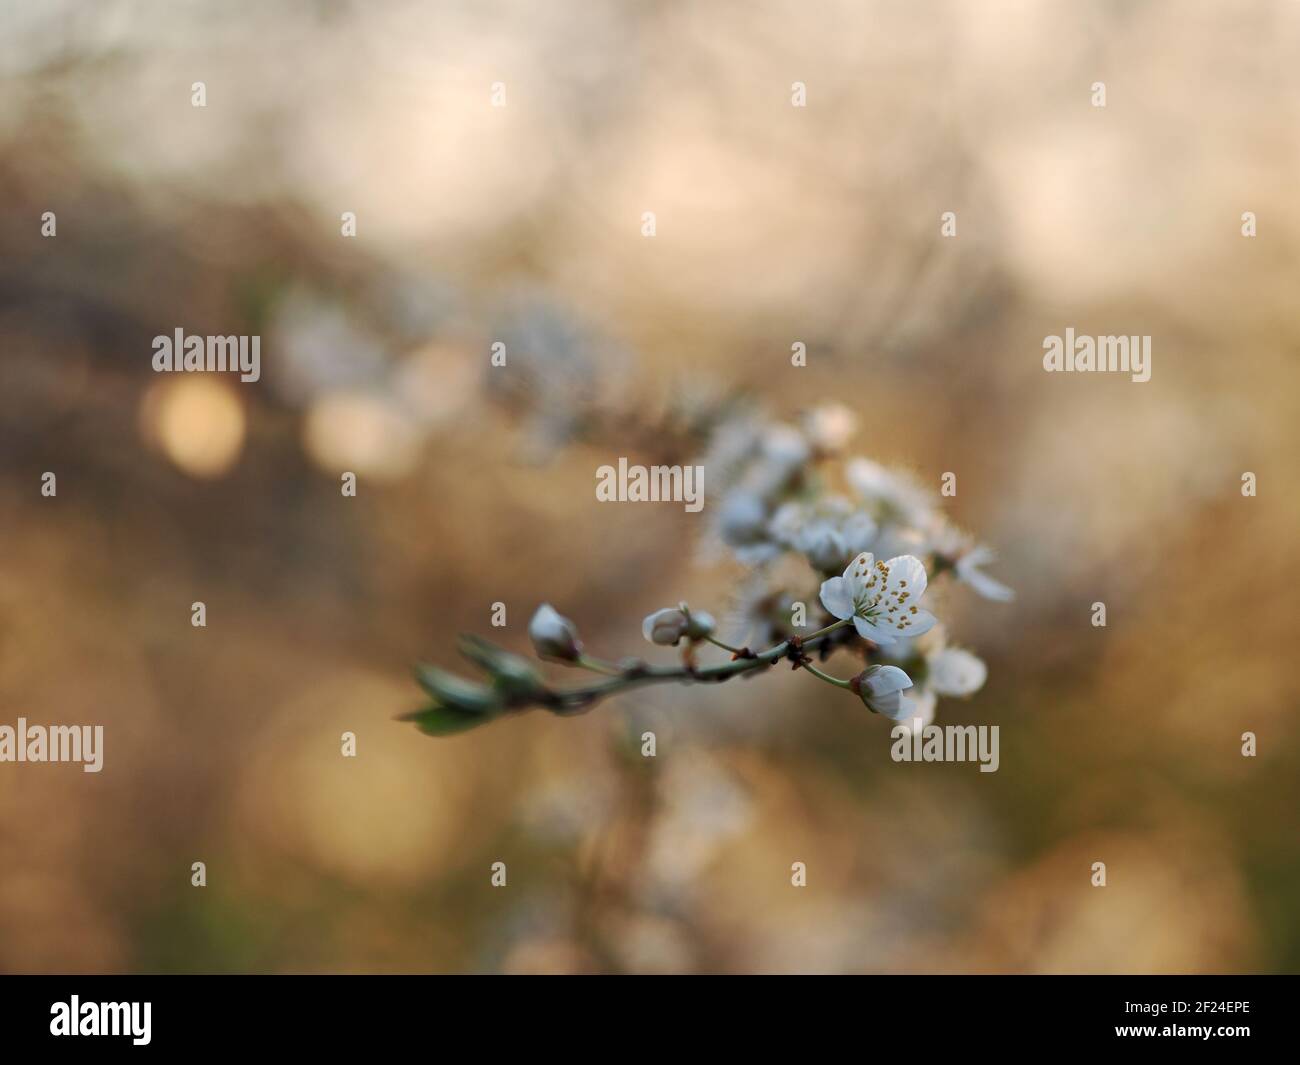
407, 407, 1013, 735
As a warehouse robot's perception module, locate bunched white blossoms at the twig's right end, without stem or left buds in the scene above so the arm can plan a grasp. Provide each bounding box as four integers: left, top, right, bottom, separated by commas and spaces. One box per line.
705, 404, 1014, 724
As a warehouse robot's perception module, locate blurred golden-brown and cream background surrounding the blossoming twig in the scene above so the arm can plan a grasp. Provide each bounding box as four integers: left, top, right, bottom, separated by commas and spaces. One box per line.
0, 0, 1300, 973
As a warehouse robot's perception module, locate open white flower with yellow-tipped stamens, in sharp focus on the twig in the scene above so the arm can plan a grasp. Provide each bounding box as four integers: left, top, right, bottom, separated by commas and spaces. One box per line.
822, 551, 935, 644
